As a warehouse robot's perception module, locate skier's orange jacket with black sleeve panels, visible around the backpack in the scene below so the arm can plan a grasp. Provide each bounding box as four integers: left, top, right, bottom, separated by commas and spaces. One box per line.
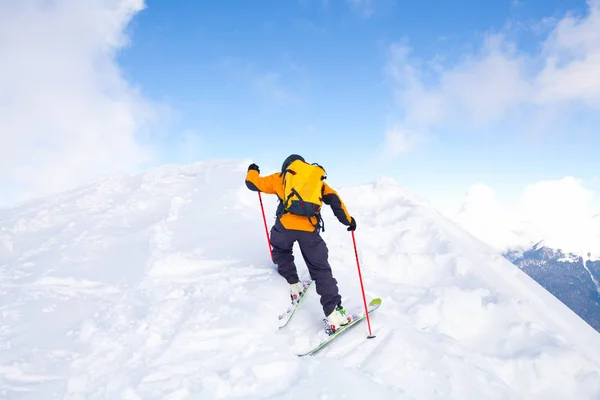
246, 169, 352, 232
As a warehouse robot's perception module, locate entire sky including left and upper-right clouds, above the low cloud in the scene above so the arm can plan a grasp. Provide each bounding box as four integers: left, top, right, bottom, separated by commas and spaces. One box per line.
0, 0, 600, 219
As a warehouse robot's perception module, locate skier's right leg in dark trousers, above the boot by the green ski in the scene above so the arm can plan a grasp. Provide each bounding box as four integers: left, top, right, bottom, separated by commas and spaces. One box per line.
298, 232, 342, 316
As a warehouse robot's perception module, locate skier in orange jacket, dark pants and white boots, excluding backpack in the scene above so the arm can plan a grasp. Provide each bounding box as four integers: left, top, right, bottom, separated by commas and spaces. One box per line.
246, 154, 356, 331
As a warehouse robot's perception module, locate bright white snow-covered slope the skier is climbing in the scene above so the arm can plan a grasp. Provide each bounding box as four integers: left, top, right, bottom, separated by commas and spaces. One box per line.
0, 161, 600, 400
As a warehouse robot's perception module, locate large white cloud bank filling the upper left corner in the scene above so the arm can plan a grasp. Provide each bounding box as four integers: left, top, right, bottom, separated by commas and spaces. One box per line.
0, 0, 151, 205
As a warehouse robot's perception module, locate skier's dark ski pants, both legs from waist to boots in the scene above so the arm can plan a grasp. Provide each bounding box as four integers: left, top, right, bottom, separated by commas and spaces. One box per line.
271, 221, 342, 316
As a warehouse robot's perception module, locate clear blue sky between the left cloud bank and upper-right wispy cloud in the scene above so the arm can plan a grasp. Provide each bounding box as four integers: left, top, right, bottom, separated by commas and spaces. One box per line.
113, 0, 600, 211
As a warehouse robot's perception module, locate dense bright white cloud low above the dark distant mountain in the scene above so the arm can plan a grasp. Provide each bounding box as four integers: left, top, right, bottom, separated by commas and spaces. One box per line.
452, 177, 600, 254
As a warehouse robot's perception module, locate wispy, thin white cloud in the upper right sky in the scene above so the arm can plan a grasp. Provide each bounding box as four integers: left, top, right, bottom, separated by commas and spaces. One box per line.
386, 0, 600, 148
